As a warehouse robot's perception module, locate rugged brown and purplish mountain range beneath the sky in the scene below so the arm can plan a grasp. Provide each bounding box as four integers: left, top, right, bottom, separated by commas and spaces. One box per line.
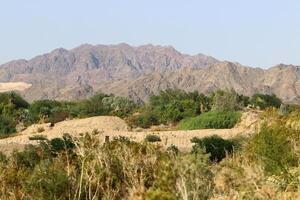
0, 44, 300, 102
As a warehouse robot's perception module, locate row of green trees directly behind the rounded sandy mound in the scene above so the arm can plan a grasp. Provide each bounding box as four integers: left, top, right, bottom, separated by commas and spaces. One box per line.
27, 93, 136, 124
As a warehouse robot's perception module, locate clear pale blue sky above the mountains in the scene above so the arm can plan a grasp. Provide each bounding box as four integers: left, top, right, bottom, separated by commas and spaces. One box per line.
0, 0, 300, 67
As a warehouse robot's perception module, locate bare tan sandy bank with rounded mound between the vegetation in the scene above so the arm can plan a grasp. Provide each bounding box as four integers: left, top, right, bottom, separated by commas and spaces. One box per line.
0, 112, 258, 153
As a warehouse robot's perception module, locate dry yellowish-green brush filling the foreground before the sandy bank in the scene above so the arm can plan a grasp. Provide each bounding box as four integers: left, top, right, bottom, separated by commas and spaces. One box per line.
0, 115, 300, 200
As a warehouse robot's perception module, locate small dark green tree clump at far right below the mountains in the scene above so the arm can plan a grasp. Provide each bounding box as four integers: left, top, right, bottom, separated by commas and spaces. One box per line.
250, 94, 282, 109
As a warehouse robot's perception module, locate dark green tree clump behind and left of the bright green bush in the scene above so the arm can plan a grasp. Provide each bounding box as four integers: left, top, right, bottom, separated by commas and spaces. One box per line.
128, 89, 211, 128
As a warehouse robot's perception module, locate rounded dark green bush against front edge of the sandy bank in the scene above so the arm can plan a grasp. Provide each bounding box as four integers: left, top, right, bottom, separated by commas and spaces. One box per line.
191, 135, 234, 162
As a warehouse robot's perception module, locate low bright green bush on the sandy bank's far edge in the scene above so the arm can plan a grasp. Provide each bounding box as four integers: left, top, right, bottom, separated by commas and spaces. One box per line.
179, 110, 241, 130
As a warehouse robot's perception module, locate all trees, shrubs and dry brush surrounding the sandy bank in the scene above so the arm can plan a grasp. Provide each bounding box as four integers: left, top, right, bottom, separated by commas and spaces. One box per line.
0, 90, 300, 200
